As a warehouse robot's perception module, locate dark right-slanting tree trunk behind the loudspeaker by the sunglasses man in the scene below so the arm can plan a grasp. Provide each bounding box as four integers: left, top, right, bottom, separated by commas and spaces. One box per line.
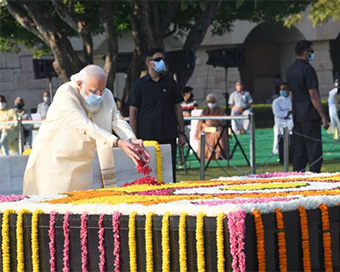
177, 0, 221, 90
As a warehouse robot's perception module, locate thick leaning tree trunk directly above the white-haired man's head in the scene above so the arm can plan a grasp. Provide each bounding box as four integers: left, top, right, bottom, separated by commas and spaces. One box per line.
17, 1, 84, 82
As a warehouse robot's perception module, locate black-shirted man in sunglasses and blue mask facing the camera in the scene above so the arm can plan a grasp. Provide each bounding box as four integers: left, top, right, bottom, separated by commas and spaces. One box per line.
129, 49, 185, 182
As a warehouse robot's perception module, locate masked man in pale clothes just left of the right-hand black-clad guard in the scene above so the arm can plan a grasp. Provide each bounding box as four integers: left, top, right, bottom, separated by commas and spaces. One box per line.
272, 83, 294, 162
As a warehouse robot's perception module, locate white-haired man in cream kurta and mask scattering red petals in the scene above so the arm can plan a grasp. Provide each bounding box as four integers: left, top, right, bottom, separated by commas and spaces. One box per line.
23, 65, 149, 195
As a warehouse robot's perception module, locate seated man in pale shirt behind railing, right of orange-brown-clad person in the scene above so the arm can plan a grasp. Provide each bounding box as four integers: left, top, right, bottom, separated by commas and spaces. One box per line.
228, 81, 253, 134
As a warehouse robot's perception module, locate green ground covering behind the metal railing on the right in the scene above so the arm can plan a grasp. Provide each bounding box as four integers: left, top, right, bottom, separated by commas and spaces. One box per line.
177, 128, 340, 180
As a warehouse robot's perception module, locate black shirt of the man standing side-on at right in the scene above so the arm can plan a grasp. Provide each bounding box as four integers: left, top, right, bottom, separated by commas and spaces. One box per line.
286, 59, 321, 122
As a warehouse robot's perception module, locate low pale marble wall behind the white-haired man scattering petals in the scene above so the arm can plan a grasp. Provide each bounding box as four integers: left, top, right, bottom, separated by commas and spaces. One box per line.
0, 145, 172, 195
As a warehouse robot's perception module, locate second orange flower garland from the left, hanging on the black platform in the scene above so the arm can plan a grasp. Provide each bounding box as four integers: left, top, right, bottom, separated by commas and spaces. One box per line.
275, 209, 287, 272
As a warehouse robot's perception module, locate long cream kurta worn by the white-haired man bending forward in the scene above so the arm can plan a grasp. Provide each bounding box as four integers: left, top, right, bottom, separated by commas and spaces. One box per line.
23, 81, 135, 195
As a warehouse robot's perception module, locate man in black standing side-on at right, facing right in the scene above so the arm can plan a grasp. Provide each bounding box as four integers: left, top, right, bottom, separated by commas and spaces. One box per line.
286, 41, 329, 173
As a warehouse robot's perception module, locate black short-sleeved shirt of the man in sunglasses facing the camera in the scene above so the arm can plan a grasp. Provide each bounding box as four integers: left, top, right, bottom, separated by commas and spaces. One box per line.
129, 75, 183, 140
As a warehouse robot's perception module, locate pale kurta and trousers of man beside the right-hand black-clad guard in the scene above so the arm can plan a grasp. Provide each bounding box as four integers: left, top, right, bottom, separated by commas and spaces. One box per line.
272, 96, 294, 154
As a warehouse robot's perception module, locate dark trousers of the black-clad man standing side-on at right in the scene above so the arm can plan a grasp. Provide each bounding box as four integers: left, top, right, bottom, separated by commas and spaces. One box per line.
293, 120, 322, 173
